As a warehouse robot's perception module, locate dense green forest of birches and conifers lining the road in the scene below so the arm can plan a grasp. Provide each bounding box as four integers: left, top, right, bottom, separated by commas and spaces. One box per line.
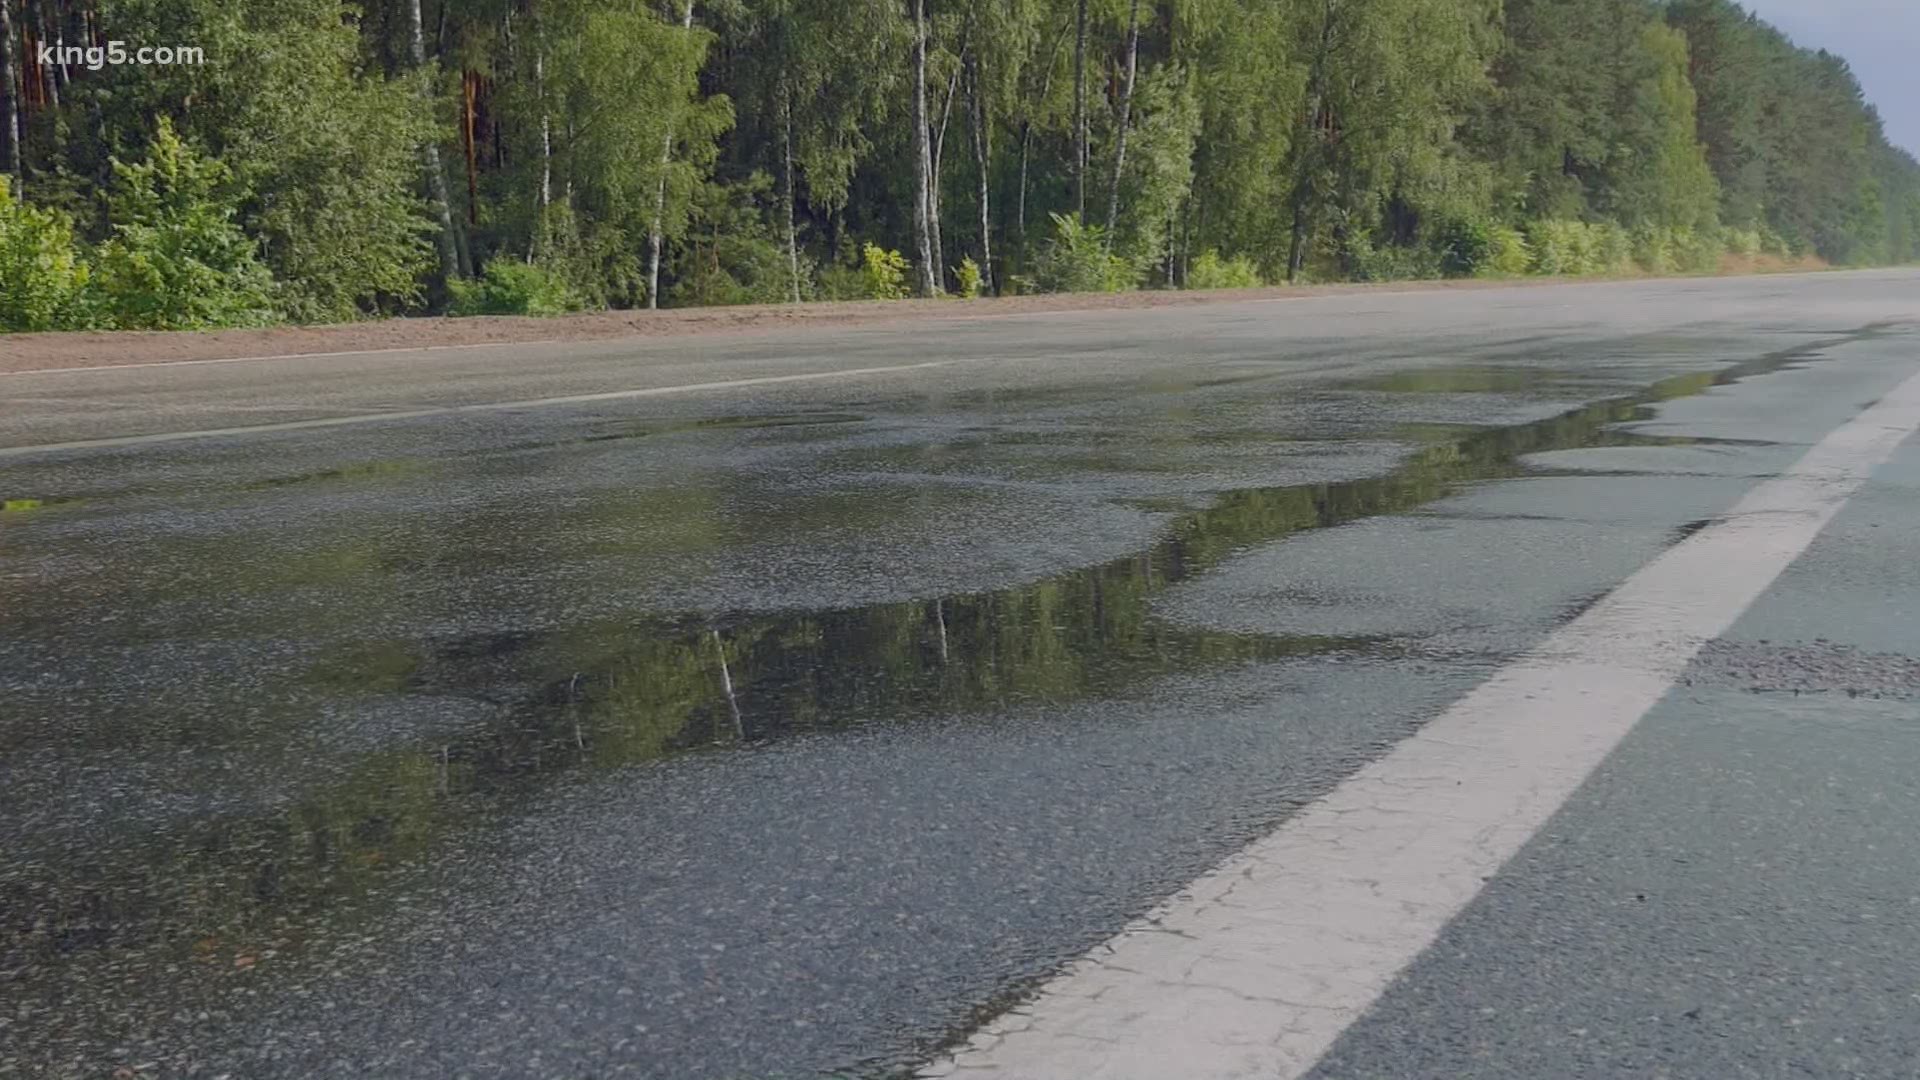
0, 0, 1920, 331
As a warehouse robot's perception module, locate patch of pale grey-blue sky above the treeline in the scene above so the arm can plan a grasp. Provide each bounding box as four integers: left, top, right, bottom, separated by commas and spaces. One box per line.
1743, 0, 1920, 154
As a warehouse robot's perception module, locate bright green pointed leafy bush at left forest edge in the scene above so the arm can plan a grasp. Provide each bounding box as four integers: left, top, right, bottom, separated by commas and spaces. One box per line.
94, 117, 280, 331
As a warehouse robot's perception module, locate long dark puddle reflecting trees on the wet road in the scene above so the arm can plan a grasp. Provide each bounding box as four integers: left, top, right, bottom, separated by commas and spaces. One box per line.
0, 332, 1881, 1006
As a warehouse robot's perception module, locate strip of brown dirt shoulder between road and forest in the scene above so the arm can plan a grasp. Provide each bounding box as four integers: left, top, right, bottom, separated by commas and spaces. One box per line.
0, 267, 1827, 373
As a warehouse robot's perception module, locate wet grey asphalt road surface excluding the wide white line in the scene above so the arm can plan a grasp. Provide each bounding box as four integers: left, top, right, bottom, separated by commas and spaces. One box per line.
0, 273, 1920, 1080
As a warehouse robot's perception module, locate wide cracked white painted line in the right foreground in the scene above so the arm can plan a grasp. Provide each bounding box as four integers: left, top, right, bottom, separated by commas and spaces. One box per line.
922, 361, 1920, 1080
